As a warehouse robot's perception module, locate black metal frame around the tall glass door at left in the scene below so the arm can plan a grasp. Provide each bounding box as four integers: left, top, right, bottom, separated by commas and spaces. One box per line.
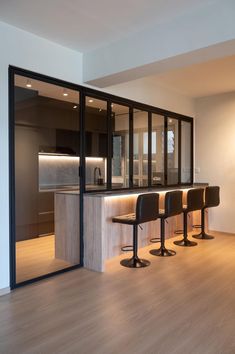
9, 66, 84, 289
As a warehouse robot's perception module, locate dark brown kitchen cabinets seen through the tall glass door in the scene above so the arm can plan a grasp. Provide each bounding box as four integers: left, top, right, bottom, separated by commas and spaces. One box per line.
15, 88, 79, 241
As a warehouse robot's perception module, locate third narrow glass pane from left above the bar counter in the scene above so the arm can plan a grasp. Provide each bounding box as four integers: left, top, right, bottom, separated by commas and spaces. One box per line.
133, 110, 148, 187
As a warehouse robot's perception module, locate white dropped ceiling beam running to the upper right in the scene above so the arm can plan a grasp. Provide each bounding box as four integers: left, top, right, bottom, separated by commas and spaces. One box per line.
83, 0, 235, 87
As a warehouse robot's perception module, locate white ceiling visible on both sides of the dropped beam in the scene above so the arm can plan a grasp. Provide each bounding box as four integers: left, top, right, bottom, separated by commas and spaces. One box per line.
4, 0, 235, 102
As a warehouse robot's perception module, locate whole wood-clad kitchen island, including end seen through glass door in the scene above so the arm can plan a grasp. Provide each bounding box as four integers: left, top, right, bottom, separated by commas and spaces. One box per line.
55, 187, 207, 272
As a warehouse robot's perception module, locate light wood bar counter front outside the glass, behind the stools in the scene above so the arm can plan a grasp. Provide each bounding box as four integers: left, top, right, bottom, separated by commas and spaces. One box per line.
84, 184, 206, 272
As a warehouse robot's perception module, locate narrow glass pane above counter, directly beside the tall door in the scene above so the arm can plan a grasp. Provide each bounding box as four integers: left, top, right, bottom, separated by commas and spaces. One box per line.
85, 97, 108, 190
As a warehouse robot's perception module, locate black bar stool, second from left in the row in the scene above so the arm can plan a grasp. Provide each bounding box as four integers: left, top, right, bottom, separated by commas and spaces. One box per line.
150, 191, 183, 257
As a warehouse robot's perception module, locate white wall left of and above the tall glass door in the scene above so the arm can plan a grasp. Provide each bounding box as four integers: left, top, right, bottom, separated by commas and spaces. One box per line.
0, 22, 82, 289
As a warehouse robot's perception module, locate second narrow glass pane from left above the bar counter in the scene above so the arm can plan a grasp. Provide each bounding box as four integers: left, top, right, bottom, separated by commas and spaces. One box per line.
111, 103, 129, 188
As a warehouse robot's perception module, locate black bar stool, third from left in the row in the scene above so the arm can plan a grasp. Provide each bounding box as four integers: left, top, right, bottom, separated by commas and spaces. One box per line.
174, 188, 204, 247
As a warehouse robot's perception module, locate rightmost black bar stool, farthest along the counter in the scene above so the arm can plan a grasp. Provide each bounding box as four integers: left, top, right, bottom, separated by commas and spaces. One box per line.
193, 186, 220, 240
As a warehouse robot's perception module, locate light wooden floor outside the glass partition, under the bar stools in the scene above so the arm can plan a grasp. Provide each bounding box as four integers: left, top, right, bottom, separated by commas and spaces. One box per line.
0, 234, 235, 354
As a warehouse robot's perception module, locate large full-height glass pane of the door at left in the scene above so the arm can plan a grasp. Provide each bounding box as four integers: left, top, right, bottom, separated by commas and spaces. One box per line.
14, 75, 80, 283
